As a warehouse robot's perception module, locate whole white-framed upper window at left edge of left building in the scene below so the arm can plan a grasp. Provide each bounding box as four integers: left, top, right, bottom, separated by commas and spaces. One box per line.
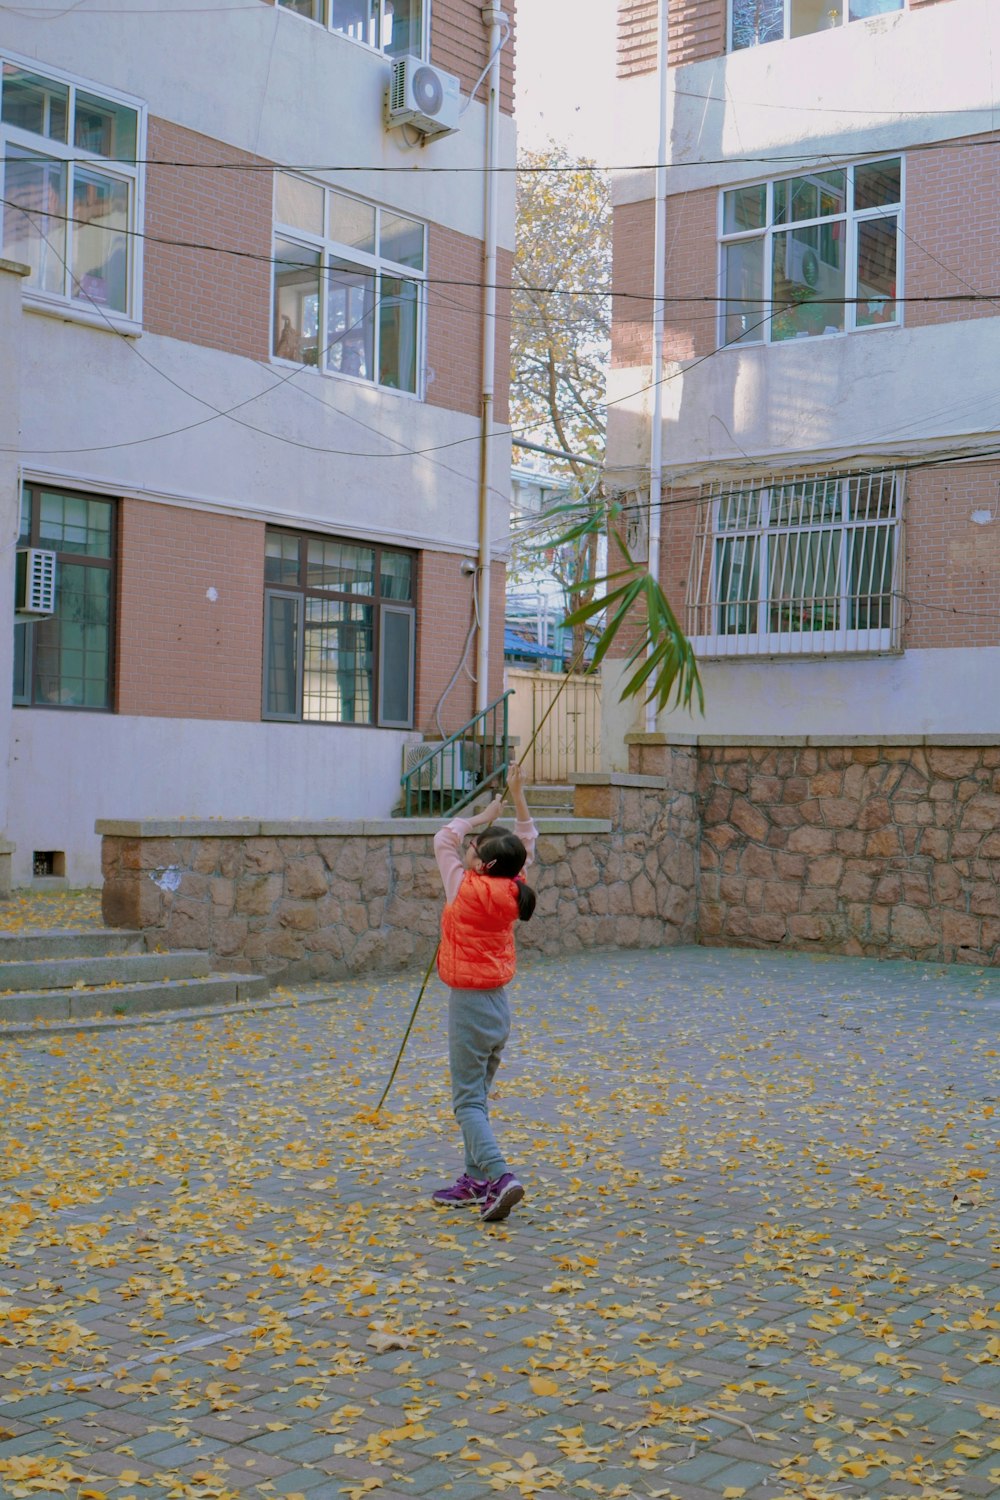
0, 60, 141, 318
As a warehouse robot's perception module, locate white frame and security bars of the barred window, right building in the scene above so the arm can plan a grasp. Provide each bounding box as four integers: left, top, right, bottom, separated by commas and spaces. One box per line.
685, 471, 904, 659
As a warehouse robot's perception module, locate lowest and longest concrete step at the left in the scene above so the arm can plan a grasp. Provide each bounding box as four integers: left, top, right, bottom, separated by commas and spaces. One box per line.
0, 972, 271, 1025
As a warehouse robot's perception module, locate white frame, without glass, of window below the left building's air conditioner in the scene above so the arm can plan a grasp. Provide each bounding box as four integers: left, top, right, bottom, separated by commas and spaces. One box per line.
270, 173, 427, 401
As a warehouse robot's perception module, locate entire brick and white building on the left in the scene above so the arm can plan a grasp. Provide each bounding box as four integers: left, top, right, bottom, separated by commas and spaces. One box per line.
0, 0, 514, 885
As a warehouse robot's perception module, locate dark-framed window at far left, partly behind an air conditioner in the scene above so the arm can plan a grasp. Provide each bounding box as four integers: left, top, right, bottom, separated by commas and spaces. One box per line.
13, 485, 114, 708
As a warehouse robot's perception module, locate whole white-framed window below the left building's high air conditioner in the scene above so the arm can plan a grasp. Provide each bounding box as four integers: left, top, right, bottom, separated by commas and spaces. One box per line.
273, 173, 426, 395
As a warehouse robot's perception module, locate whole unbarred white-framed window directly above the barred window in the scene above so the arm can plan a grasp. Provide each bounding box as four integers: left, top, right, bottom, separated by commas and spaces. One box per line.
720, 156, 903, 344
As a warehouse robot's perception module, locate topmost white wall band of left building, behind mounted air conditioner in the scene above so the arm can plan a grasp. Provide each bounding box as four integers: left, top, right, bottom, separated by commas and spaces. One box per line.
0, 0, 514, 248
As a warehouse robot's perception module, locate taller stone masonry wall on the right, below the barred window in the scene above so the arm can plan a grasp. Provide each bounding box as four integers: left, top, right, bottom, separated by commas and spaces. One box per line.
699, 741, 1000, 965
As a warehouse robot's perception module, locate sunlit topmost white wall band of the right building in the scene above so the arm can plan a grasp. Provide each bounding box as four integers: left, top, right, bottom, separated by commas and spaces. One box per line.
613, 0, 1000, 203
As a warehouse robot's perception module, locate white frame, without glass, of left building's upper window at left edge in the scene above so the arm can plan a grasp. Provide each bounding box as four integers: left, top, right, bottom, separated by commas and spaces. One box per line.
0, 50, 147, 333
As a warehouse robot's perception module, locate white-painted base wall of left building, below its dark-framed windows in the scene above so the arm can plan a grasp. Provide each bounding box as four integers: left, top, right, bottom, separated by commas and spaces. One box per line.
7, 696, 417, 887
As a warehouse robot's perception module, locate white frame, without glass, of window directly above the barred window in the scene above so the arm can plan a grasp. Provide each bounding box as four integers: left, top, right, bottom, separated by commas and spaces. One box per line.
717, 153, 906, 350
